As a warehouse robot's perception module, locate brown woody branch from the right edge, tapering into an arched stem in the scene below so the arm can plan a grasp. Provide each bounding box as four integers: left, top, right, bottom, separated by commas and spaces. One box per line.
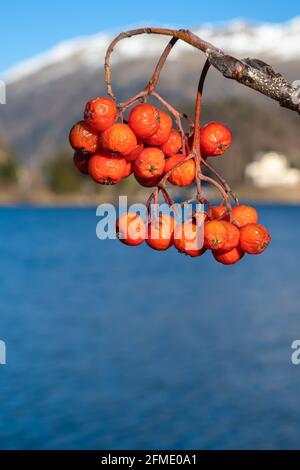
105, 28, 300, 114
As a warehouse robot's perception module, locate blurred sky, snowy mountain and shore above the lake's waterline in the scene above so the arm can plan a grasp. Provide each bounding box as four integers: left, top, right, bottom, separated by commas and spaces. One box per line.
0, 1, 300, 204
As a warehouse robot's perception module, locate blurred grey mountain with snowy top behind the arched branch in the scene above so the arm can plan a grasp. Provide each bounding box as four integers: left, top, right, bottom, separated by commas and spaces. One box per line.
0, 17, 300, 169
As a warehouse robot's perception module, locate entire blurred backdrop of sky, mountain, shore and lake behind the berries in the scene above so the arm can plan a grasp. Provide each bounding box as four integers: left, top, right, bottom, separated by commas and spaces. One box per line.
0, 0, 300, 449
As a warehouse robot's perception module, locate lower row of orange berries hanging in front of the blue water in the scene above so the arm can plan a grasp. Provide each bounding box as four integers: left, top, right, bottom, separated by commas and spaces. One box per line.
117, 205, 270, 265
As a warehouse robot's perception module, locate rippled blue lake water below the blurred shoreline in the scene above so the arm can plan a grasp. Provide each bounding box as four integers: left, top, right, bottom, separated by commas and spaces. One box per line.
0, 206, 300, 449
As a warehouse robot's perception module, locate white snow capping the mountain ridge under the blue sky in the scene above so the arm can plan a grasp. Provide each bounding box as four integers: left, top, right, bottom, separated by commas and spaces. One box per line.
4, 17, 300, 83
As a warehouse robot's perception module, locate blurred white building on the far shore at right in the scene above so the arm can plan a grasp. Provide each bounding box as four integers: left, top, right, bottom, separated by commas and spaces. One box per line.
245, 152, 300, 188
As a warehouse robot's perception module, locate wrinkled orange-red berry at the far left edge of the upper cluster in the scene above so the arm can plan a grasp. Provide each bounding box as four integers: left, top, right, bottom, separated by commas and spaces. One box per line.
69, 121, 98, 153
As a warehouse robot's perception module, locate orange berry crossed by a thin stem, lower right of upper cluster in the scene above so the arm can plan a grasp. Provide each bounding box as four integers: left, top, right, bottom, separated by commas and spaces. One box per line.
165, 154, 196, 186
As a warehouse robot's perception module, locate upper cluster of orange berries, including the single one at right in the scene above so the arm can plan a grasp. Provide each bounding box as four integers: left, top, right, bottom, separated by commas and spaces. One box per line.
70, 98, 218, 187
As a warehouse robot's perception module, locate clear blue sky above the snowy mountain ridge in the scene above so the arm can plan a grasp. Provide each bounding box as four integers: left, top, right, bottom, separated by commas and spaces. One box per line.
0, 0, 300, 72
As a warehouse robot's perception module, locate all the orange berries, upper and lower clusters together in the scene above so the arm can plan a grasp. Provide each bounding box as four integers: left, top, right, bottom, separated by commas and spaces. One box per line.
70, 97, 270, 264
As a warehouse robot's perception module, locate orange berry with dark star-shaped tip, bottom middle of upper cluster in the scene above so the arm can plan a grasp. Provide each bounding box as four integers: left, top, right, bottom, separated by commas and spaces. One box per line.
133, 147, 165, 179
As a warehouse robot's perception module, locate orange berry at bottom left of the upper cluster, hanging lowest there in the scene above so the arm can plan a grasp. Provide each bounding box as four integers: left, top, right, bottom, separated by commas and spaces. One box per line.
89, 151, 126, 184
